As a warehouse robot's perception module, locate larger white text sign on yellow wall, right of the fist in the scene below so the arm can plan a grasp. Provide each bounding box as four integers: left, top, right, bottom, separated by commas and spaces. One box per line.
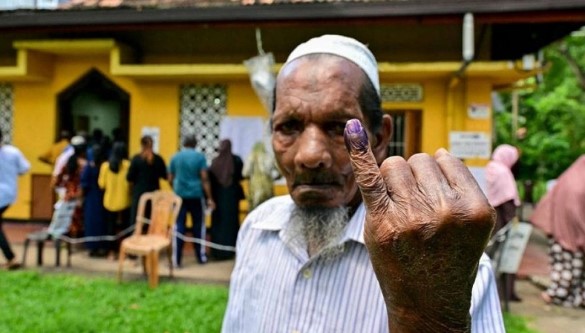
449, 132, 492, 159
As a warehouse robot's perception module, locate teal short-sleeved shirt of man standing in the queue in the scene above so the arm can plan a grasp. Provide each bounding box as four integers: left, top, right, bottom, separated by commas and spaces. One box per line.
169, 148, 207, 199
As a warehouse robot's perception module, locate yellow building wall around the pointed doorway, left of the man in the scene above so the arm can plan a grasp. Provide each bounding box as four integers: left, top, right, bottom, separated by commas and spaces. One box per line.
5, 55, 274, 219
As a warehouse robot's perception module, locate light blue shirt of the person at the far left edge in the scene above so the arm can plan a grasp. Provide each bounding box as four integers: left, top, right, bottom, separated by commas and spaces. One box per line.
0, 145, 30, 208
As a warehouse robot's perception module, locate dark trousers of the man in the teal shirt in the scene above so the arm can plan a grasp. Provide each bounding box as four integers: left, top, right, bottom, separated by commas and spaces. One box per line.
174, 198, 207, 266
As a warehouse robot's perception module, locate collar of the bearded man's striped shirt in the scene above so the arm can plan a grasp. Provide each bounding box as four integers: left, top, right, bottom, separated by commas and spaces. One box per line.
252, 196, 366, 244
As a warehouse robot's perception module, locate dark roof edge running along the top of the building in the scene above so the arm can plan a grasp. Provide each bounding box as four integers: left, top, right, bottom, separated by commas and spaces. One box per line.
0, 0, 585, 29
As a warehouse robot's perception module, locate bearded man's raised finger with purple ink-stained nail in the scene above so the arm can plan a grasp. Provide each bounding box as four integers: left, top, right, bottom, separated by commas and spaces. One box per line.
343, 119, 389, 211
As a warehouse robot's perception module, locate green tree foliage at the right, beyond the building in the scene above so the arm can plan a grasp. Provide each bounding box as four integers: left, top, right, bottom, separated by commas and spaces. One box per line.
495, 34, 585, 181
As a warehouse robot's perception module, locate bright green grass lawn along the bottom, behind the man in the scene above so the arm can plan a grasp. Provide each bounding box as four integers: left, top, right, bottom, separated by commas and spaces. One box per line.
0, 271, 537, 333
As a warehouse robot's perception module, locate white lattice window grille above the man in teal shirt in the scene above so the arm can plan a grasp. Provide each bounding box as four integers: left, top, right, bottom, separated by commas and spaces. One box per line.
179, 84, 227, 164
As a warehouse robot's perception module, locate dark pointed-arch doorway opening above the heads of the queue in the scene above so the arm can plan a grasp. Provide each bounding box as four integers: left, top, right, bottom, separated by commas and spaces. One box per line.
57, 69, 130, 144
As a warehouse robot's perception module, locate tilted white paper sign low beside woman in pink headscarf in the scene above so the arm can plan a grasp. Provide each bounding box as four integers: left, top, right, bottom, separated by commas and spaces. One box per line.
498, 222, 532, 274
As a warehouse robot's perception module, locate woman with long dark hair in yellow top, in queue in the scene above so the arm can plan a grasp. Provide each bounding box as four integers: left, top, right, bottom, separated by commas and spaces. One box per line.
98, 141, 130, 260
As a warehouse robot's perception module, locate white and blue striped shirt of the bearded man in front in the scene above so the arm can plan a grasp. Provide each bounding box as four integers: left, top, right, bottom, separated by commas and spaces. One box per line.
222, 196, 505, 333
